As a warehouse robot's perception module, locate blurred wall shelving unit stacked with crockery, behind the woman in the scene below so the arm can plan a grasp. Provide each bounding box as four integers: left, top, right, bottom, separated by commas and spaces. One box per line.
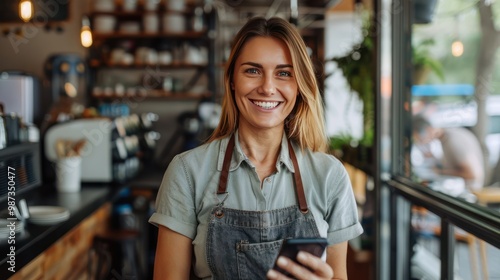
89, 1, 216, 109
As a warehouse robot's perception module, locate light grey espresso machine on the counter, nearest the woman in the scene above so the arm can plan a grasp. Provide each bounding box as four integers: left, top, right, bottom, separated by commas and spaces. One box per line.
44, 113, 159, 183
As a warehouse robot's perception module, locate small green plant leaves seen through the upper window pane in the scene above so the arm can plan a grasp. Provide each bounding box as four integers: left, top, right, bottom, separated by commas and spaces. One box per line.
412, 38, 444, 83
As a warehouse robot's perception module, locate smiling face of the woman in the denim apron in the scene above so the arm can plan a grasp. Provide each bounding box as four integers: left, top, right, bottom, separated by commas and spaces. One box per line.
231, 37, 298, 133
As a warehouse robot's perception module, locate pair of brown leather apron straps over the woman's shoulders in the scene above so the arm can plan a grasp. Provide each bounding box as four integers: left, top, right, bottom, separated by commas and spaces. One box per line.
217, 133, 309, 213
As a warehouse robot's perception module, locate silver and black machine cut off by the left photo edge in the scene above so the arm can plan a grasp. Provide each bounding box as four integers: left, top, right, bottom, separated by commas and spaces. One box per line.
0, 71, 42, 200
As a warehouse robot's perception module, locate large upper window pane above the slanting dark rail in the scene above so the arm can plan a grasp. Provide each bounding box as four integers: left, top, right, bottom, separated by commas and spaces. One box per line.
410, 0, 500, 212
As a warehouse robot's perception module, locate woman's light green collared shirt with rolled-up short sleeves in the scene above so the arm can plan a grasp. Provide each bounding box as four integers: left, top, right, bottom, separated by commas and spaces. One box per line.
149, 133, 363, 278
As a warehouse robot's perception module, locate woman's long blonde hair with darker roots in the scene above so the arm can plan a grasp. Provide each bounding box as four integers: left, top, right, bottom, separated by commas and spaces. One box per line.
209, 17, 328, 151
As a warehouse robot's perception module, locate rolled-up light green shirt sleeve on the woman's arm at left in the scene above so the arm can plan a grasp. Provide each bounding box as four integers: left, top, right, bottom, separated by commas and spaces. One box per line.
149, 155, 197, 239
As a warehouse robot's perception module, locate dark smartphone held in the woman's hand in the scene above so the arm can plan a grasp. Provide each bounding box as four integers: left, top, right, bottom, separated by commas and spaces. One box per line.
273, 238, 328, 276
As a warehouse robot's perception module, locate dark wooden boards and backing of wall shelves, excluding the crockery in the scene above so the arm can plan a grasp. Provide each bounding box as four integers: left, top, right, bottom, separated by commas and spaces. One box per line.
89, 6, 216, 102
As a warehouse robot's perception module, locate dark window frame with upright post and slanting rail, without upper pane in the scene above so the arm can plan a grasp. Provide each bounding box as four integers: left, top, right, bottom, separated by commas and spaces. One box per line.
374, 0, 500, 279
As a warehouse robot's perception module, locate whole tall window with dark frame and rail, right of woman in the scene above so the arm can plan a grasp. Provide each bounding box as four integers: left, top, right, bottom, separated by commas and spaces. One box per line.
375, 0, 500, 279
